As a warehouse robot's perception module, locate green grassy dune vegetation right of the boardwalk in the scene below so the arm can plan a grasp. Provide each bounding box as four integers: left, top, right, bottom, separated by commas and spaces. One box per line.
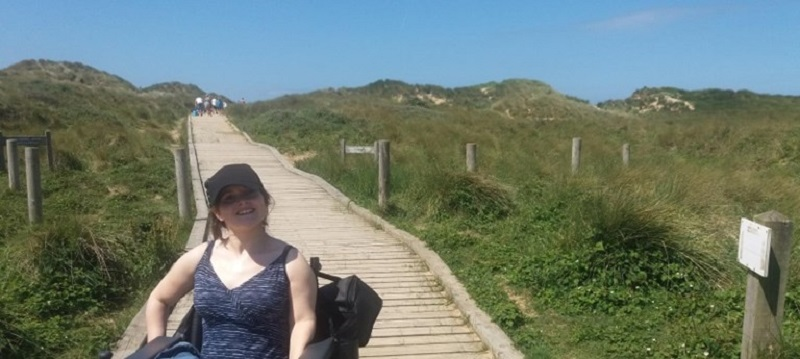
228, 80, 800, 358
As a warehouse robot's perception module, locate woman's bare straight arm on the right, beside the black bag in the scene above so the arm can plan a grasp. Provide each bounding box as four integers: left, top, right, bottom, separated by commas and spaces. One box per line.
286, 249, 317, 359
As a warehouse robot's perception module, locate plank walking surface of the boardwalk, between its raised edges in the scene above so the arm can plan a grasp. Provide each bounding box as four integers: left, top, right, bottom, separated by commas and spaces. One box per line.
115, 116, 500, 359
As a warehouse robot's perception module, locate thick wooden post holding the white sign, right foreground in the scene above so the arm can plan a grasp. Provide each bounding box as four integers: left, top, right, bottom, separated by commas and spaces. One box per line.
741, 211, 792, 359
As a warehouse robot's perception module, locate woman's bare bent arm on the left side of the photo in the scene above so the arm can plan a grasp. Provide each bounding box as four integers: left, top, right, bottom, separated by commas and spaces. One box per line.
145, 243, 206, 342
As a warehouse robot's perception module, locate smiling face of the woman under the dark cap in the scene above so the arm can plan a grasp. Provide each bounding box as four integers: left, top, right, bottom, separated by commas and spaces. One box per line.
214, 185, 267, 231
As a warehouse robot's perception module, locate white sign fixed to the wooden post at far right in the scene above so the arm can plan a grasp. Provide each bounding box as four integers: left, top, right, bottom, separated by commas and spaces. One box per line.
739, 218, 772, 278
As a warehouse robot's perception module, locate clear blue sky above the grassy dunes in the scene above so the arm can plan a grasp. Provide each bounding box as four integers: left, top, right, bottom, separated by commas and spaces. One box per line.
0, 0, 800, 103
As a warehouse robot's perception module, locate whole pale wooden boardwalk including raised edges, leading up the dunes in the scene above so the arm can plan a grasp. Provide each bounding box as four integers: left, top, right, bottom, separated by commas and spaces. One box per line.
114, 116, 522, 359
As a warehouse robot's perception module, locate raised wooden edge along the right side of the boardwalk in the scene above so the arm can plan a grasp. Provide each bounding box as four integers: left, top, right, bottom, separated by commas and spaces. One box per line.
234, 126, 524, 359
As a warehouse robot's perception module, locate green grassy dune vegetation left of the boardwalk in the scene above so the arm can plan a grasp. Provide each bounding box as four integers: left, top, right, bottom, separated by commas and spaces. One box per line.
0, 60, 202, 359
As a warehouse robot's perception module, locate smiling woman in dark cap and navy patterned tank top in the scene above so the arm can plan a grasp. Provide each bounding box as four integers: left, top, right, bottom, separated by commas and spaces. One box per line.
145, 164, 317, 359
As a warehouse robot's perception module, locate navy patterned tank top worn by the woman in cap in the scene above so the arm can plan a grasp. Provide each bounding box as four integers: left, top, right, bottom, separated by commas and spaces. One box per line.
194, 241, 292, 359
